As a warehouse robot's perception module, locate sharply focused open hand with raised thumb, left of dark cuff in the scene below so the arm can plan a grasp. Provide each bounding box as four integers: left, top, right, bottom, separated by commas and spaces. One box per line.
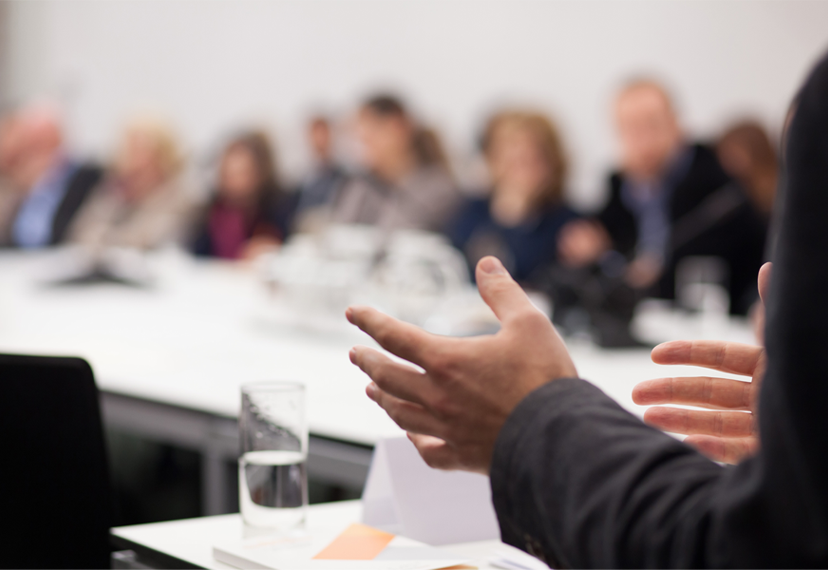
346, 257, 576, 474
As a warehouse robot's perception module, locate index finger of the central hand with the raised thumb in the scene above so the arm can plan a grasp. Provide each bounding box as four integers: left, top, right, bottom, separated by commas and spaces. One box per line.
345, 307, 434, 364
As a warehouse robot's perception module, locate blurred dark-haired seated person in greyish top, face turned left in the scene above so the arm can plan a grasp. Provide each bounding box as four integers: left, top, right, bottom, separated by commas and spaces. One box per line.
331, 95, 460, 231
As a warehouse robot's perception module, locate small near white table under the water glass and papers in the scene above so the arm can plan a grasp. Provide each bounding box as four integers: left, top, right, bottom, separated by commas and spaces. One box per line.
112, 501, 515, 570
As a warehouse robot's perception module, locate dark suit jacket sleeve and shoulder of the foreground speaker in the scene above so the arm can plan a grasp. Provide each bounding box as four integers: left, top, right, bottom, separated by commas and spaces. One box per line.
492, 48, 828, 570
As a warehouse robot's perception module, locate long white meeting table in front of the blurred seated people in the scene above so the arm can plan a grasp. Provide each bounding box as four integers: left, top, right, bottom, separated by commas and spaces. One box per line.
0, 252, 750, 514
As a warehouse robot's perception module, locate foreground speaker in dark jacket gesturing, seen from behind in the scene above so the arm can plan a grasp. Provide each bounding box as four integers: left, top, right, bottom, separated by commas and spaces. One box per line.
347, 51, 828, 570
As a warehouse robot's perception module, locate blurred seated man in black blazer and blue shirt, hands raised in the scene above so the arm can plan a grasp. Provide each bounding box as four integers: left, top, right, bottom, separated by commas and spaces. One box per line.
559, 80, 766, 314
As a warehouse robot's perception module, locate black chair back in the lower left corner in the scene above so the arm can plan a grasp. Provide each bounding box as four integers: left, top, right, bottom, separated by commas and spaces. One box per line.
0, 355, 111, 570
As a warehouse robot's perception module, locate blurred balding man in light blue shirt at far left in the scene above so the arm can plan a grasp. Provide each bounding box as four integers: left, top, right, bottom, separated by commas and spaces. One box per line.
10, 105, 102, 248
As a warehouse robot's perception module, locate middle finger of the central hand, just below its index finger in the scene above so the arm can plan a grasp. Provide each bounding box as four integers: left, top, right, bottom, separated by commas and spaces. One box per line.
348, 346, 431, 406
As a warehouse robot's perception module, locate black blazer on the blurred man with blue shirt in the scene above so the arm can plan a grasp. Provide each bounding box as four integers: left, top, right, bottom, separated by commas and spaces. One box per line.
597, 144, 767, 314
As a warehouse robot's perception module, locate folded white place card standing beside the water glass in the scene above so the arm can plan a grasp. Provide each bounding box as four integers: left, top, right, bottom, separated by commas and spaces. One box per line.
362, 437, 500, 545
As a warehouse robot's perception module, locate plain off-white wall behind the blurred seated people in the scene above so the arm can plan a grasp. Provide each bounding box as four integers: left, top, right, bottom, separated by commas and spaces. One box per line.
3, 0, 828, 209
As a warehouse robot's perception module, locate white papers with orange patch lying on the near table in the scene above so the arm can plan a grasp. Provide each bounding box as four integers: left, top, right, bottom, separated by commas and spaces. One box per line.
213, 524, 472, 570
